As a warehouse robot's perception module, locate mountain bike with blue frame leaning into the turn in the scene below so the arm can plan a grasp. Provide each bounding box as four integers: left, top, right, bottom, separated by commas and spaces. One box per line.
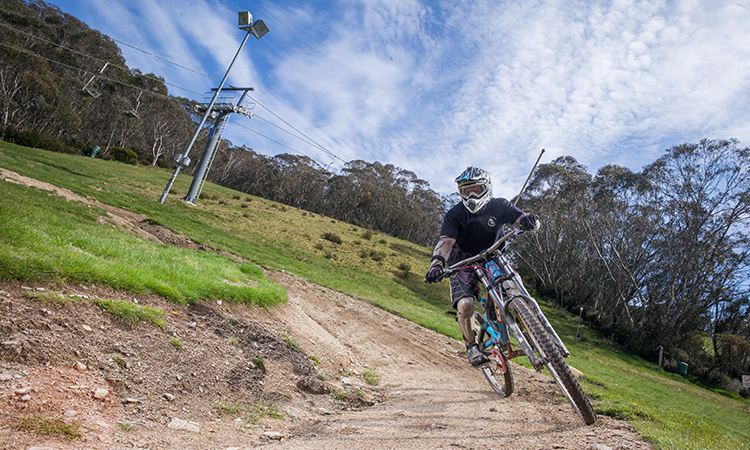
438, 228, 596, 425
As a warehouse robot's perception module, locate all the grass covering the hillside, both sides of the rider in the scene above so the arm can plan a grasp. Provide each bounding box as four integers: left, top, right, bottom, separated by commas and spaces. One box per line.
0, 142, 750, 449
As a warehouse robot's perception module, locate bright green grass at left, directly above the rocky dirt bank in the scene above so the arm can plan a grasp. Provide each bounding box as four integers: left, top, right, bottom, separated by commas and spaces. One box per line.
0, 177, 286, 305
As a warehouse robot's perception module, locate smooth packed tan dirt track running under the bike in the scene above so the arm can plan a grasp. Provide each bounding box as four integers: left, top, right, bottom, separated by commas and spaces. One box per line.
254, 274, 650, 449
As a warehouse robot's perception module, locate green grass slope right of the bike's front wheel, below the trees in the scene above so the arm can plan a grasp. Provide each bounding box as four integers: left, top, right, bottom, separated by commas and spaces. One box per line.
541, 303, 750, 450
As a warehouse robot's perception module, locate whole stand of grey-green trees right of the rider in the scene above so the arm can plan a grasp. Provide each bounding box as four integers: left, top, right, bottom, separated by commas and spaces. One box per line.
517, 140, 750, 395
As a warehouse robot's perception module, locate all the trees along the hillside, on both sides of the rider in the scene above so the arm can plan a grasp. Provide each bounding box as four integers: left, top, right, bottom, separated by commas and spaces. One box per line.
0, 0, 750, 395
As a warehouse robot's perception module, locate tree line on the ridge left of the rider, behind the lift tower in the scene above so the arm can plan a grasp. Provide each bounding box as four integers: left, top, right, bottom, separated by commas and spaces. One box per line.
0, 0, 443, 244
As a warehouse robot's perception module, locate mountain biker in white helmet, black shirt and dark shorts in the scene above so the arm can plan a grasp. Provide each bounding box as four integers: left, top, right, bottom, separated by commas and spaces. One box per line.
425, 167, 537, 366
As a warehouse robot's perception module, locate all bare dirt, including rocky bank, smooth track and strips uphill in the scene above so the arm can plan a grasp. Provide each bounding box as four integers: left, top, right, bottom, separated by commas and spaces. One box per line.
0, 171, 652, 450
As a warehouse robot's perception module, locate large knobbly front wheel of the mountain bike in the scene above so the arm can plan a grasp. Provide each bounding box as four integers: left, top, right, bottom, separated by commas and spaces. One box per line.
510, 295, 596, 425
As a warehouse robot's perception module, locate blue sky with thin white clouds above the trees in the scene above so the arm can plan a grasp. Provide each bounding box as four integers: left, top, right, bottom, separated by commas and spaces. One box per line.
49, 0, 750, 197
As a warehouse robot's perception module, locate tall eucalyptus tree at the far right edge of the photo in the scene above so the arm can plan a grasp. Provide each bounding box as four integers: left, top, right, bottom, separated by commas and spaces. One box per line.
642, 140, 750, 356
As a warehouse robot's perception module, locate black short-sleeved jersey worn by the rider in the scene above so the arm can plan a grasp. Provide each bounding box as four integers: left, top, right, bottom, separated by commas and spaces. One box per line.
440, 198, 523, 263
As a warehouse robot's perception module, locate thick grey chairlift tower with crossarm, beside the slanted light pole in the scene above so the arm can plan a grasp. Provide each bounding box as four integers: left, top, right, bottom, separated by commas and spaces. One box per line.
183, 87, 254, 205
